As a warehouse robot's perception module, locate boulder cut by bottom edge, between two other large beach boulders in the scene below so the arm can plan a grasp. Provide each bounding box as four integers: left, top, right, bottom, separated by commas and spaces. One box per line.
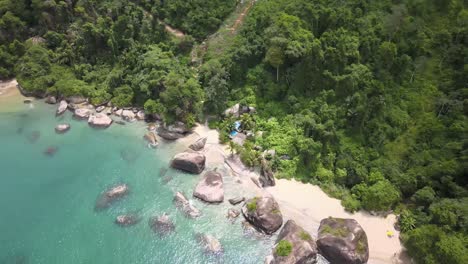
271, 220, 317, 264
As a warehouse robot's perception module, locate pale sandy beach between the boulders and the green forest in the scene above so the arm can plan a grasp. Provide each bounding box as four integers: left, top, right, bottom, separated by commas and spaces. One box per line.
0, 80, 409, 264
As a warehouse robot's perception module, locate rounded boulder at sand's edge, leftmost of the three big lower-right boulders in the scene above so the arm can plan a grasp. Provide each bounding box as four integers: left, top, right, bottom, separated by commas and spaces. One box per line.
242, 197, 283, 235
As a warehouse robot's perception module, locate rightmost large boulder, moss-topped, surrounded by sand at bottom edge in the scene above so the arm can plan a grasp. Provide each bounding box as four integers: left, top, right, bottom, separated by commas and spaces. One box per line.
317, 217, 369, 264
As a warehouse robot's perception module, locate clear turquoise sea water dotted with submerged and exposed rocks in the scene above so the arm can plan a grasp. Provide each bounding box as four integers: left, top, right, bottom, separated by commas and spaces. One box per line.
0, 102, 274, 264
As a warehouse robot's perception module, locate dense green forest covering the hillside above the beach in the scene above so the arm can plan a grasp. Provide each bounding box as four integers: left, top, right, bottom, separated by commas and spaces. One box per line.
0, 0, 468, 264
